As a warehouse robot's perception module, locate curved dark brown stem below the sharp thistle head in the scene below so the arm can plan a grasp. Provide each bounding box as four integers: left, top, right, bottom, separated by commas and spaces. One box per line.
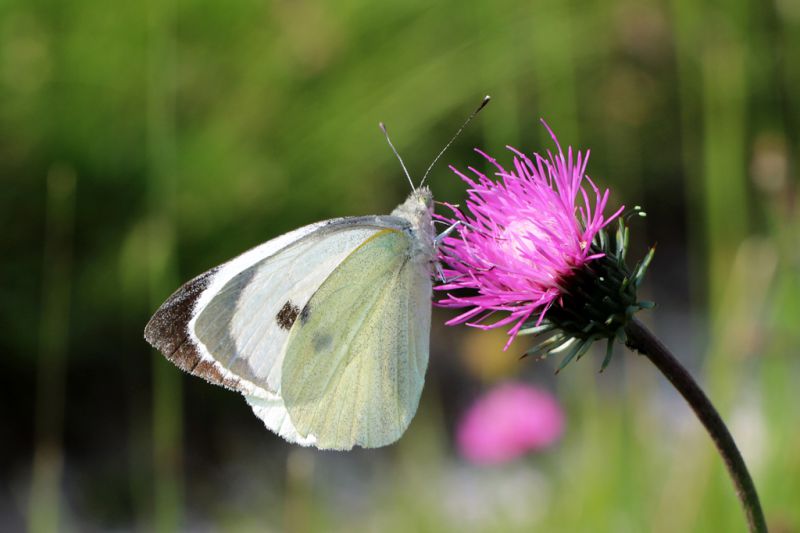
625, 318, 767, 533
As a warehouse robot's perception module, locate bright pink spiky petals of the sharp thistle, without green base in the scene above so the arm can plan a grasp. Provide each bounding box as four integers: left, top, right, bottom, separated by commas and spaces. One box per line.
436, 122, 623, 348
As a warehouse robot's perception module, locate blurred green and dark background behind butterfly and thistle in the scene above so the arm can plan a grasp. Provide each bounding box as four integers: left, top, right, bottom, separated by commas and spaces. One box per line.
0, 0, 800, 532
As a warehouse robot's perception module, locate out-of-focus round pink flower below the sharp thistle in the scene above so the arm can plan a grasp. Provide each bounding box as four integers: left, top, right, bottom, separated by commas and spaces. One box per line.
456, 383, 564, 464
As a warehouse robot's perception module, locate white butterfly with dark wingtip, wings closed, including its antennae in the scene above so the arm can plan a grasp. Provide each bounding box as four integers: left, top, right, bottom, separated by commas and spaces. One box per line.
144, 97, 488, 450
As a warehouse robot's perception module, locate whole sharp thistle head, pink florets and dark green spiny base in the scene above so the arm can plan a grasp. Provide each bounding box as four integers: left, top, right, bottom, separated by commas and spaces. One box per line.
437, 121, 653, 370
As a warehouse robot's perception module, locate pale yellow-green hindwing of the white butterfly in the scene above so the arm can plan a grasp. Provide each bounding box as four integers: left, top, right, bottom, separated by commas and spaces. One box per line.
281, 230, 431, 449
